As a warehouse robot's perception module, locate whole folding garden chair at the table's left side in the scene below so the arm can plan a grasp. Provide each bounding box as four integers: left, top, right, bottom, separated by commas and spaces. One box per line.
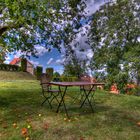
40, 73, 60, 108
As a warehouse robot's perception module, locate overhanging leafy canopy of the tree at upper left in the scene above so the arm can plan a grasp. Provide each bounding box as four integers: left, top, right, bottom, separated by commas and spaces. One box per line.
0, 0, 85, 55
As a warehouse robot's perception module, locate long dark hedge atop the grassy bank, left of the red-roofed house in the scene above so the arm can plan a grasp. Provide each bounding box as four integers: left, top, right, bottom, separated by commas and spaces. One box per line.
0, 64, 20, 71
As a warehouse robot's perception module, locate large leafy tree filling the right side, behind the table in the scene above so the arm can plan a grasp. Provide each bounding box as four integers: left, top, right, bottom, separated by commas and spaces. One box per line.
90, 0, 140, 93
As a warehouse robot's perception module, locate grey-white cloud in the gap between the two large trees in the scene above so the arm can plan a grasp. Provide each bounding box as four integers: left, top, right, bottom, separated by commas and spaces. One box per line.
62, 0, 107, 63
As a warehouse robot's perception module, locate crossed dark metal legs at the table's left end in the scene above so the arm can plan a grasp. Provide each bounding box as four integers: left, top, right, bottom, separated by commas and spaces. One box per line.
56, 86, 69, 118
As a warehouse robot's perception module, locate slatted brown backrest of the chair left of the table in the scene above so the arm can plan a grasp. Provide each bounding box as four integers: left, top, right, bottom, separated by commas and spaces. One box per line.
40, 73, 51, 90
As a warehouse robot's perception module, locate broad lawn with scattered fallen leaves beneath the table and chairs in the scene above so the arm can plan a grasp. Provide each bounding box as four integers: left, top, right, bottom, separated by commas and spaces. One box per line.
0, 80, 140, 140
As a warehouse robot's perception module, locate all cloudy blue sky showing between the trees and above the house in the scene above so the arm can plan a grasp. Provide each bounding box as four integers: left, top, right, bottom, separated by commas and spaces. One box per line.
5, 0, 106, 74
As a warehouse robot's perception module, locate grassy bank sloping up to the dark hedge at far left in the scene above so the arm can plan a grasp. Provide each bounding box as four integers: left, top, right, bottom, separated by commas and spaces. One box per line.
0, 71, 35, 81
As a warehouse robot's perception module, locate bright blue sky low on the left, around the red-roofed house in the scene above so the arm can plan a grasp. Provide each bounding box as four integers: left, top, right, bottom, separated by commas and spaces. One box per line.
5, 47, 63, 73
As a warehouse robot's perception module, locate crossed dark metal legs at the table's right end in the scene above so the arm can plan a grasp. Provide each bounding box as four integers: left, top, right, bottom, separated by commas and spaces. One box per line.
80, 85, 94, 112
